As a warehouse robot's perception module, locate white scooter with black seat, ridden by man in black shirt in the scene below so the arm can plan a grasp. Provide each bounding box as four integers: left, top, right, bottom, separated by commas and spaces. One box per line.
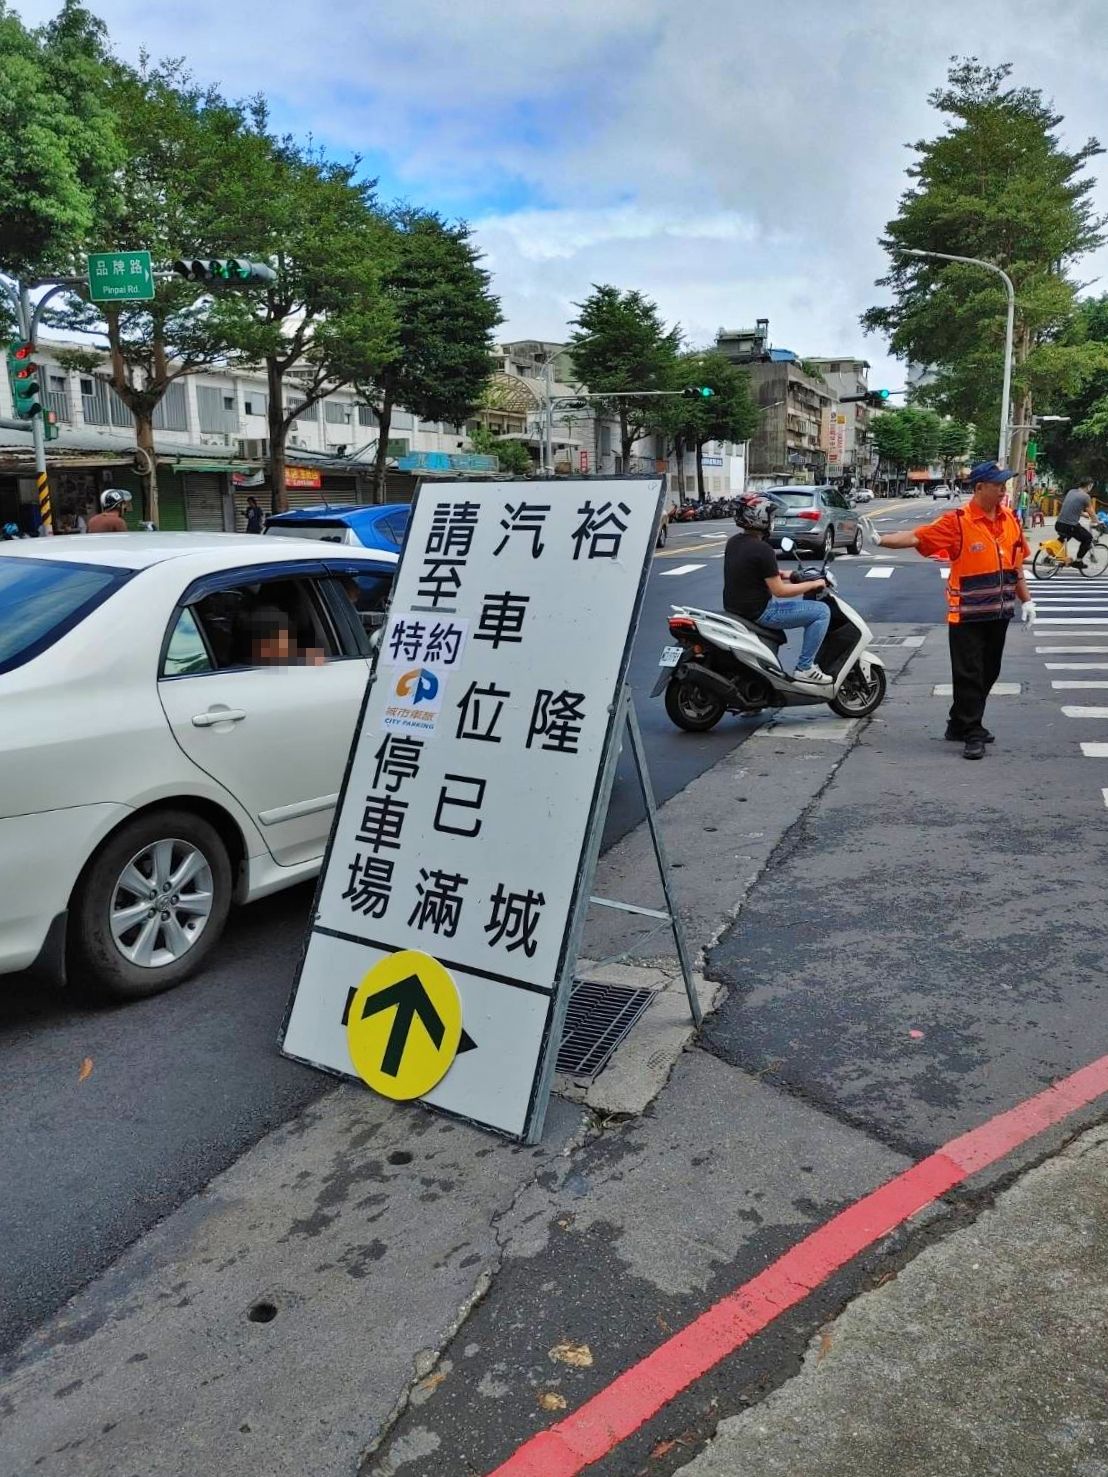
652, 539, 888, 733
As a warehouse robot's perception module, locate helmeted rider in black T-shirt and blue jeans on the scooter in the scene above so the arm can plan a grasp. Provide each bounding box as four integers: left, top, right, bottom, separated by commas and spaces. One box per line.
724, 493, 832, 687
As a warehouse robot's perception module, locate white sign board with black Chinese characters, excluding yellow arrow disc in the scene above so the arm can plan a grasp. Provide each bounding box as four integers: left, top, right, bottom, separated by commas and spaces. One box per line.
282, 477, 663, 1142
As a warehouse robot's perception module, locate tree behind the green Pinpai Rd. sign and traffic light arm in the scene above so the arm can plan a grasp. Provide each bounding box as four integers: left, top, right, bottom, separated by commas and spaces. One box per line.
47, 59, 283, 523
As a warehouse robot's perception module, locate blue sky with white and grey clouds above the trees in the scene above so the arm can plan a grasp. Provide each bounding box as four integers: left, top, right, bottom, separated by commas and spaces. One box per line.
13, 0, 1108, 388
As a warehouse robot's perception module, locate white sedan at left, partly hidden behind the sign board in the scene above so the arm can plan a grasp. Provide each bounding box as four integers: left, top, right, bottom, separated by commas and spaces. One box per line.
0, 533, 399, 1000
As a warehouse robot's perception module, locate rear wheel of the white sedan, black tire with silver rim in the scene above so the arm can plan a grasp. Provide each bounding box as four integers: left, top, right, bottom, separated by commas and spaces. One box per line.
68, 808, 232, 1000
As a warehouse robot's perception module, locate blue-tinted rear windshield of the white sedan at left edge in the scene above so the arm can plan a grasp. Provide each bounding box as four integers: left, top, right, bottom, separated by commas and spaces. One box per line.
0, 557, 133, 672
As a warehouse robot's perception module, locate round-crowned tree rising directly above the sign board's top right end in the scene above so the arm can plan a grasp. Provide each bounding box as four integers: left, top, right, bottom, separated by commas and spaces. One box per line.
569, 285, 681, 470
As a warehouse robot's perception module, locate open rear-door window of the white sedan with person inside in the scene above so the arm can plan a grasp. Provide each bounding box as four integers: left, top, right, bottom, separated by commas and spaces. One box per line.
189, 576, 344, 672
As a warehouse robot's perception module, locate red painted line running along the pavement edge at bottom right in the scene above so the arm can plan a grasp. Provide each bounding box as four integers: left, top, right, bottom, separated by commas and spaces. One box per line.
489, 1056, 1108, 1477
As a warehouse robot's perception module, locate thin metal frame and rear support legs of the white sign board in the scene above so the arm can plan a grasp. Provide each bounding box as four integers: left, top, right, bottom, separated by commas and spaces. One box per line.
278, 474, 700, 1143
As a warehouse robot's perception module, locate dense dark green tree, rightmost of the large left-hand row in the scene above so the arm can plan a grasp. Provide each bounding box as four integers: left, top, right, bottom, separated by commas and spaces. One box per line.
358, 205, 511, 501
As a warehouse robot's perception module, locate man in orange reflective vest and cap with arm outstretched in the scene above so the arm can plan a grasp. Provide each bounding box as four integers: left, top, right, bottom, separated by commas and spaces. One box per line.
863, 462, 1034, 759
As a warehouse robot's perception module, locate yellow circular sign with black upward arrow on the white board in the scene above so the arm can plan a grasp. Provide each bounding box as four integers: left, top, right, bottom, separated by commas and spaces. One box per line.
346, 948, 461, 1102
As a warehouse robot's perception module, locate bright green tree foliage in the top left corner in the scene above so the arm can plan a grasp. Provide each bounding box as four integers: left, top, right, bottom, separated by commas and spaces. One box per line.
0, 0, 124, 278
